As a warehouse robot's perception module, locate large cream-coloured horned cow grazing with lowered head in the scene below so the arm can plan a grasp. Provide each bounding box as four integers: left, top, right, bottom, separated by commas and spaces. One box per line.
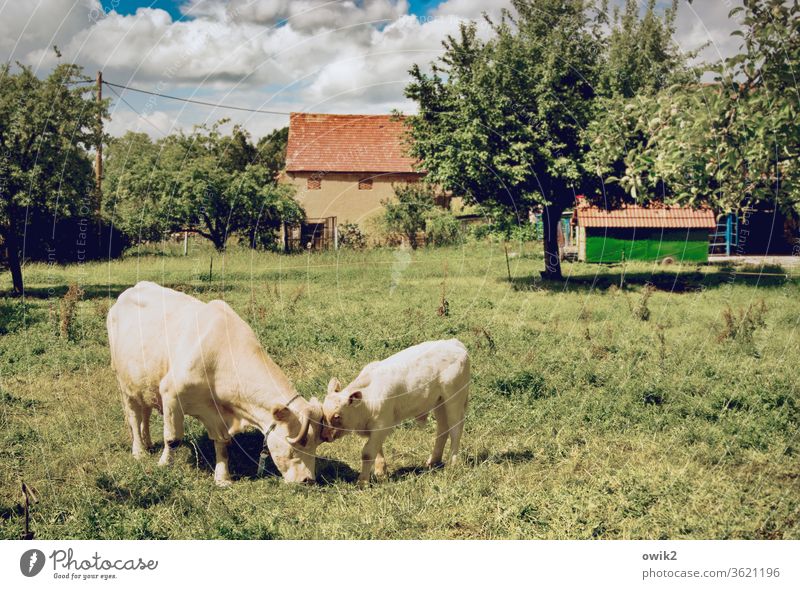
107, 282, 322, 485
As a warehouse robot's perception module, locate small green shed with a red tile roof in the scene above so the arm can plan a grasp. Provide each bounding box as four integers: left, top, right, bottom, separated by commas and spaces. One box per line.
573, 203, 717, 263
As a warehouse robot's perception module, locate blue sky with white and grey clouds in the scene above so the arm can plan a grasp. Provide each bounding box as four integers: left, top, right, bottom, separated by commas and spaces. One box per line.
0, 0, 741, 138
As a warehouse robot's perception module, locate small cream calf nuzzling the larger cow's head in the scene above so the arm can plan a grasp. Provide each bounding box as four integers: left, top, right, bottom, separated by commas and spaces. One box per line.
322, 339, 470, 484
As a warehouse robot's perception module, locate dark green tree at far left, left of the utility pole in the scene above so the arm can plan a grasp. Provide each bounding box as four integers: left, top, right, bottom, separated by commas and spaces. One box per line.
0, 64, 107, 294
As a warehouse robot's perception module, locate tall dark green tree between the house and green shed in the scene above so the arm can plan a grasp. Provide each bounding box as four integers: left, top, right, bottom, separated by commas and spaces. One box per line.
406, 0, 602, 279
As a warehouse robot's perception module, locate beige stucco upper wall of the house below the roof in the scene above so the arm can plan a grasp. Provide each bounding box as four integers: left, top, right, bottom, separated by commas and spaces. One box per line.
281, 172, 420, 229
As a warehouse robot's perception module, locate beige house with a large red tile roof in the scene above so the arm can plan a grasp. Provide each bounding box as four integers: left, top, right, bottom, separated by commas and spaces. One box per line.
281, 113, 424, 248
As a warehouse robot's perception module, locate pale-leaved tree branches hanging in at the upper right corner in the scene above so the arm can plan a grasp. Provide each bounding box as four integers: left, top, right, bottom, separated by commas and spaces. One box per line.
593, 0, 800, 212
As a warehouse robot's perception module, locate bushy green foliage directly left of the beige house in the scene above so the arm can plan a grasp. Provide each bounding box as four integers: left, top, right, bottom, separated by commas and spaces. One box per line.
106, 120, 304, 251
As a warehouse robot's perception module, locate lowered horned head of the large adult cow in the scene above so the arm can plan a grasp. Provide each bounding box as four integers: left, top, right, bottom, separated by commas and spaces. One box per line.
265, 399, 322, 483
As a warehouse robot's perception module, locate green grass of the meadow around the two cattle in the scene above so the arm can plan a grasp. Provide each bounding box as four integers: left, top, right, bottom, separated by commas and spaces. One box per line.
0, 243, 800, 539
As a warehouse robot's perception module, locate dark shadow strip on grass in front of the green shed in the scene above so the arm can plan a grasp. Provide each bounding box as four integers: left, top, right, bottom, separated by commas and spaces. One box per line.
511, 266, 789, 293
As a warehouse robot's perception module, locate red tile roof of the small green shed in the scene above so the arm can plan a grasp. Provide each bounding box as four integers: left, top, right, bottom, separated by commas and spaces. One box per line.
575, 204, 717, 229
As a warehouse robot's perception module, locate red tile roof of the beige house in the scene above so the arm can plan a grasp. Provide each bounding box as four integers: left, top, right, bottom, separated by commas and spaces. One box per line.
286, 113, 415, 173
